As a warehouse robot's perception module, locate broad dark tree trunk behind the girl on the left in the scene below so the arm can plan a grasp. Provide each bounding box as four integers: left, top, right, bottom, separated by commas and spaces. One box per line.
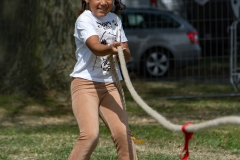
0, 0, 80, 96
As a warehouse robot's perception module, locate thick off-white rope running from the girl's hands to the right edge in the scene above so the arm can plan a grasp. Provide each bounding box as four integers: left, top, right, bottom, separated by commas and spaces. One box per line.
118, 46, 240, 133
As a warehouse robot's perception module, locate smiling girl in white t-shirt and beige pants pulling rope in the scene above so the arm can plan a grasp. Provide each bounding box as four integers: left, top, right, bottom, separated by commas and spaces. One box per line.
69, 0, 137, 160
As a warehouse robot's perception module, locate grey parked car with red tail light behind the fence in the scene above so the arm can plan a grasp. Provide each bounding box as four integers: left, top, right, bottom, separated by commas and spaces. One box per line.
119, 8, 201, 77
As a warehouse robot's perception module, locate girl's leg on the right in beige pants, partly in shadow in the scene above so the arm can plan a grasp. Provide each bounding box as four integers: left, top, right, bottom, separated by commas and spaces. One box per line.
100, 84, 137, 160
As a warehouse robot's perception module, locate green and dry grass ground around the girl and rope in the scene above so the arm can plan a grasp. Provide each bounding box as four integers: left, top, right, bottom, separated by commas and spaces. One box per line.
0, 81, 240, 160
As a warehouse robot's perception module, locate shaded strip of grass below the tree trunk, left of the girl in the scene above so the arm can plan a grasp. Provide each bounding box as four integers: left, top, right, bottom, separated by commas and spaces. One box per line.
0, 95, 72, 125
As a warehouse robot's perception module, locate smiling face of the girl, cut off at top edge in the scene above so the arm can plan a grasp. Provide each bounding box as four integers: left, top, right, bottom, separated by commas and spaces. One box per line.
86, 0, 113, 17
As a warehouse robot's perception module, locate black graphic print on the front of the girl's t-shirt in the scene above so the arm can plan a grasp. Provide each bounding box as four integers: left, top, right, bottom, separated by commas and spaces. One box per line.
93, 20, 118, 75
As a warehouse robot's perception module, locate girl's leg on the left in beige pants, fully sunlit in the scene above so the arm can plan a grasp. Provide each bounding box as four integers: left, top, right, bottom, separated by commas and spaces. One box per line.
69, 78, 99, 160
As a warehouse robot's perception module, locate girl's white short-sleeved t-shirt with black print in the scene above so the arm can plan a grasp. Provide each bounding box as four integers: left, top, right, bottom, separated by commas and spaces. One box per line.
70, 10, 127, 82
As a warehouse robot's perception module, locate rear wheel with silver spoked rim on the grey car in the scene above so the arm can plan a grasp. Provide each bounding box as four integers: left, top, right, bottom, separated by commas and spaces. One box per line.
143, 49, 170, 77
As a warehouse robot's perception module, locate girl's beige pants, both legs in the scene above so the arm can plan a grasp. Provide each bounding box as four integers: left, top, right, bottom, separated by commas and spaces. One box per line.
69, 78, 137, 160
